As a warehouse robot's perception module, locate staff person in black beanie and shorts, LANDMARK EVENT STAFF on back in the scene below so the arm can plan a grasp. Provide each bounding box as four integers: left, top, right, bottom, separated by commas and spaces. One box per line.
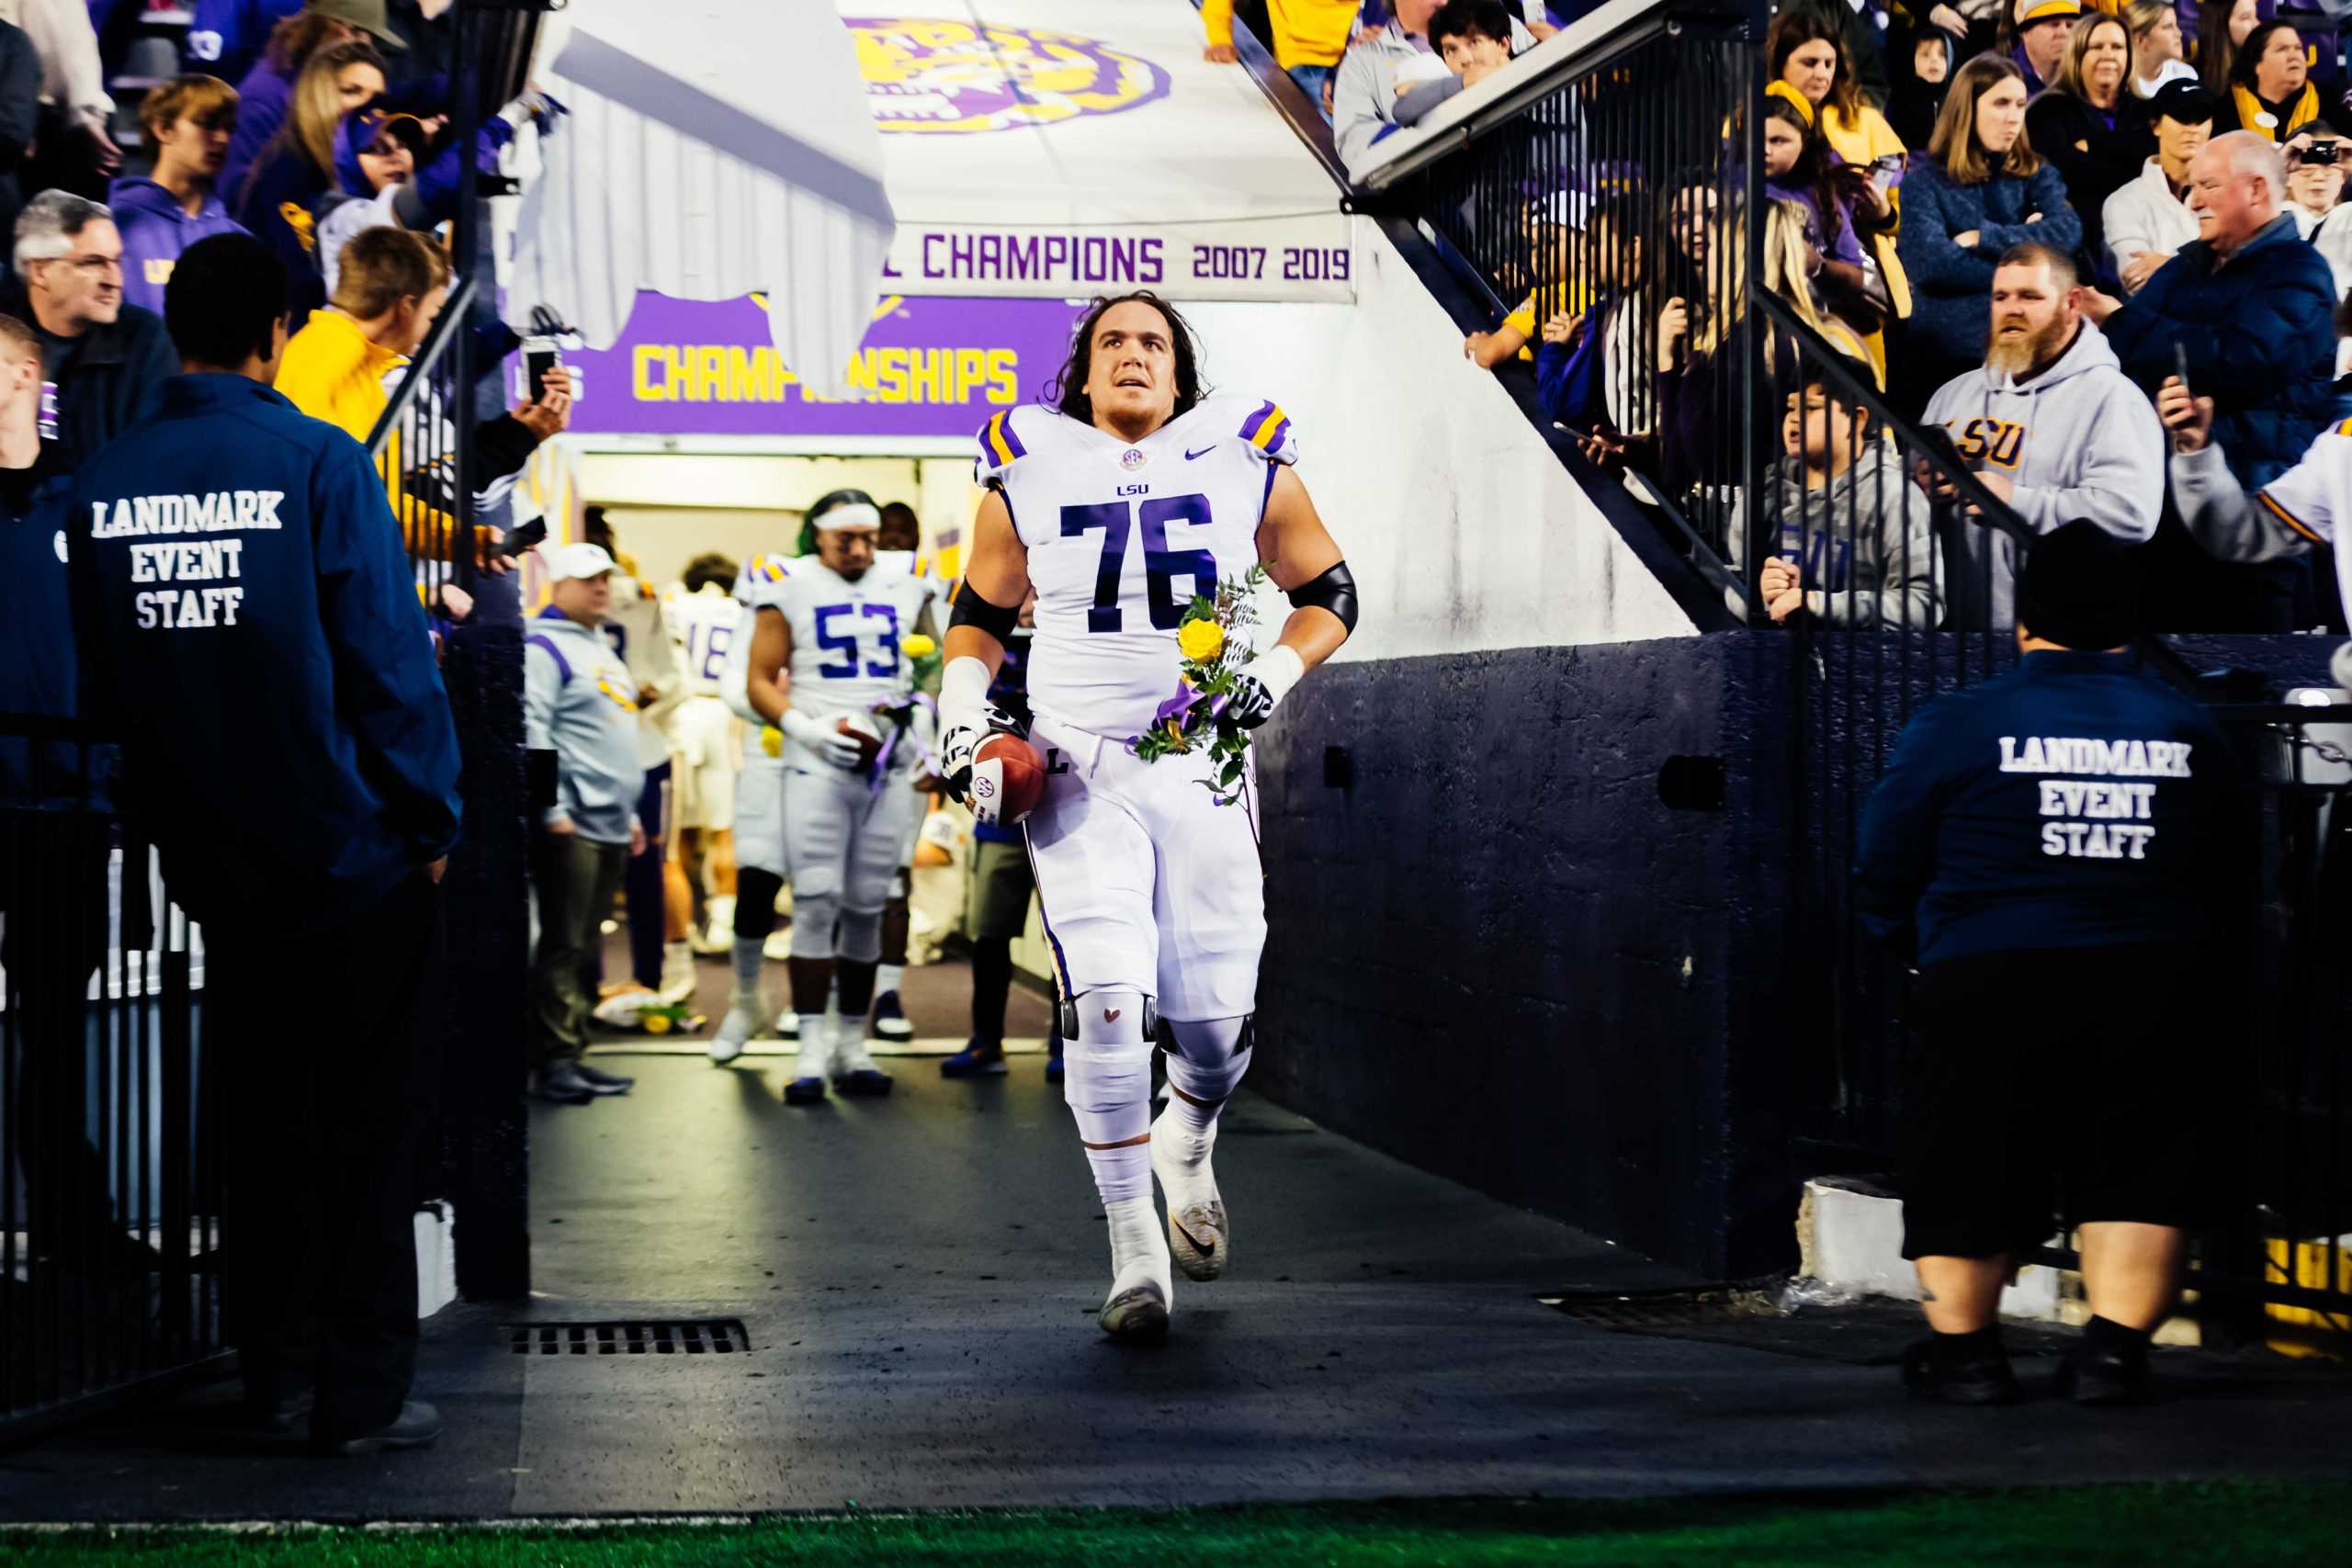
1856, 522, 2246, 1404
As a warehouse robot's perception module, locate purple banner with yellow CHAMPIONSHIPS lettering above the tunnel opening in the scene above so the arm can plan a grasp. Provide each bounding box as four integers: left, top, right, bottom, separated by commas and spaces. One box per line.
567, 294, 1080, 437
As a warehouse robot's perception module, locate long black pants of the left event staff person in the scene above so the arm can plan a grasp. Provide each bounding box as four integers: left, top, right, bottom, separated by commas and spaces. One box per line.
205, 872, 445, 1438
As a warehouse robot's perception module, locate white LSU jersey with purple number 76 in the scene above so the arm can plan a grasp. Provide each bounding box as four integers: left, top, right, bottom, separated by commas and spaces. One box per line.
978, 398, 1298, 740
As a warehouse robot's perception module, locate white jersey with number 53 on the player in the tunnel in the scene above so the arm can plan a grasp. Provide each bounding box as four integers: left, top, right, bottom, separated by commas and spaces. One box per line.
743, 555, 936, 719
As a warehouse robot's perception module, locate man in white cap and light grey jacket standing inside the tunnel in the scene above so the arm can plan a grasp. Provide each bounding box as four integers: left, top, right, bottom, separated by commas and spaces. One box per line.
522, 546, 644, 1105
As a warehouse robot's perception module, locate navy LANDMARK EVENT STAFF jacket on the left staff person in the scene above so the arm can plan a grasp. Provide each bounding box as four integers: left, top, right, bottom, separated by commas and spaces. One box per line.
73, 374, 458, 924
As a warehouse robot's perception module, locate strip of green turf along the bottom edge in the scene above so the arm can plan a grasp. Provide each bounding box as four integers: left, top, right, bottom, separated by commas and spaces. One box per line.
0, 1481, 2352, 1568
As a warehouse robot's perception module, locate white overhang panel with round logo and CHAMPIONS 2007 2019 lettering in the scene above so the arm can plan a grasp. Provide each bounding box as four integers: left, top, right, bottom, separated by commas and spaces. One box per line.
840, 0, 1355, 303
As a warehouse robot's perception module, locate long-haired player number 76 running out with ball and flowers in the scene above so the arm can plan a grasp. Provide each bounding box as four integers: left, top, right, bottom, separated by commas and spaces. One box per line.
941, 294, 1355, 1340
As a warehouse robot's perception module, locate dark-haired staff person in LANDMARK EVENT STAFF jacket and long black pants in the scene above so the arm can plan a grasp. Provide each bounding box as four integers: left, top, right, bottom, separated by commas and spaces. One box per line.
73, 235, 458, 1453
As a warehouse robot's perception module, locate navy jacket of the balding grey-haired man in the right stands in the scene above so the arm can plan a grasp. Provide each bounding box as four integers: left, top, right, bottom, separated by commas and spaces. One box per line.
2100, 216, 2338, 489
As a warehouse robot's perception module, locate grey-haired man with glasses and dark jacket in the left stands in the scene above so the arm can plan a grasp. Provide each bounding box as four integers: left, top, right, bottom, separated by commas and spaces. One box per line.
0, 190, 179, 468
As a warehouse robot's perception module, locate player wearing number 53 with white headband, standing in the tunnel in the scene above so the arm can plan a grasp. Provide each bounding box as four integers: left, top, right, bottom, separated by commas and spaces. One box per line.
736, 489, 933, 1105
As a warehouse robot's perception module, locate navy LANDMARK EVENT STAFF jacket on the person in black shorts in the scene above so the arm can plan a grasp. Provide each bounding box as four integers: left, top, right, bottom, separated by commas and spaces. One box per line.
1853, 651, 2251, 966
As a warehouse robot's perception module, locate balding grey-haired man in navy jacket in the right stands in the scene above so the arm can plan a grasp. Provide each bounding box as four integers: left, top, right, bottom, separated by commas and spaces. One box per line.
2084, 131, 2335, 632
